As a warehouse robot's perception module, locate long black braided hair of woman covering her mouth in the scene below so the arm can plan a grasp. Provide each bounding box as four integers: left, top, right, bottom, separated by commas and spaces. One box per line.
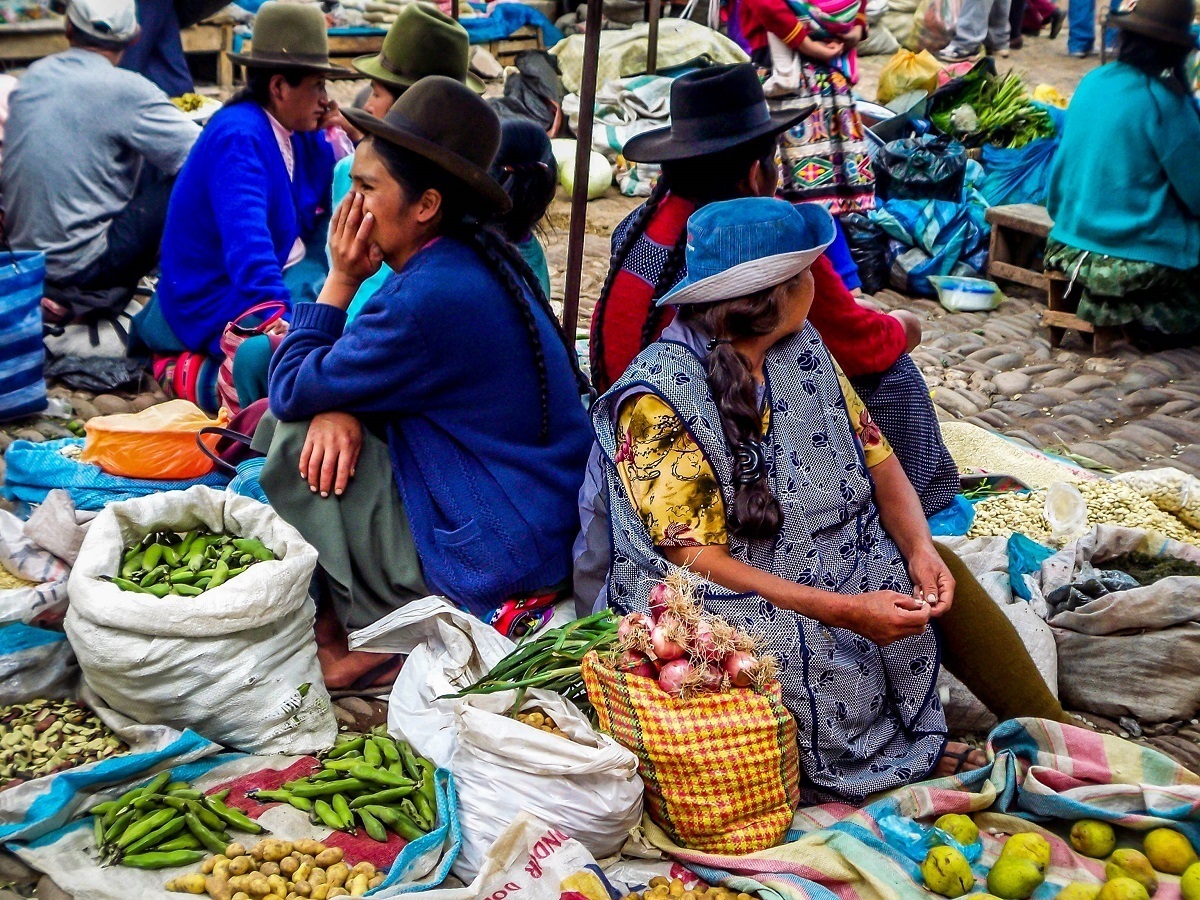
368, 138, 590, 444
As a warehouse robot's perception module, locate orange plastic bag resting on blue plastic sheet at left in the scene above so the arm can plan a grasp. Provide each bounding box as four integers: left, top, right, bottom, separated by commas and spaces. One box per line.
79, 400, 229, 481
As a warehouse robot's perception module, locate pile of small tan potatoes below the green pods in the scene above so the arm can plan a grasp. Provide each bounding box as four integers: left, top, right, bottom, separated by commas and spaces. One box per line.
167, 840, 386, 900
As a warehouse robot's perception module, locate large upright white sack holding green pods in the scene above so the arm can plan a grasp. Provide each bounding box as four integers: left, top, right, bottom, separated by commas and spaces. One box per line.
66, 487, 337, 754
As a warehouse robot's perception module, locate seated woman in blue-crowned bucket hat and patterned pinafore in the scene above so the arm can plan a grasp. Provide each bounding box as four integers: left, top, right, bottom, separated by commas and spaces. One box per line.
592, 198, 1064, 802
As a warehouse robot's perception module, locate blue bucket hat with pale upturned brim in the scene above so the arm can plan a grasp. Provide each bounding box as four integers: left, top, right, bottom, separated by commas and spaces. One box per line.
659, 197, 836, 306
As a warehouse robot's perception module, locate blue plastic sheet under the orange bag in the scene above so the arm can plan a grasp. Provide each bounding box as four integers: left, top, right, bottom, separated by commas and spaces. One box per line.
0, 438, 229, 510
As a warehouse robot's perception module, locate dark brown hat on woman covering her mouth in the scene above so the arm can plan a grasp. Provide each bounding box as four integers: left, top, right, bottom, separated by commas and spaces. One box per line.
344, 76, 512, 212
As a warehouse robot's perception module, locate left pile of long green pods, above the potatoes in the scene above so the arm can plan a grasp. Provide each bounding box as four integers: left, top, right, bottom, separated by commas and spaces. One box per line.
90, 772, 264, 869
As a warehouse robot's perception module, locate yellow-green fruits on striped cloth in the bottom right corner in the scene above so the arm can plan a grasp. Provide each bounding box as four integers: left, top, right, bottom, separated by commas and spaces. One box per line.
920, 814, 1200, 900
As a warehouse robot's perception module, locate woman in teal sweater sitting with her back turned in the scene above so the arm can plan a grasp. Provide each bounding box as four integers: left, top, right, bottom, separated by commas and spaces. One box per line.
1045, 0, 1200, 343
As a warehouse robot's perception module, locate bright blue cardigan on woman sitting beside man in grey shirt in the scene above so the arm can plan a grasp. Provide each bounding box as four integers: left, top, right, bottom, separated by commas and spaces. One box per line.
158, 101, 334, 354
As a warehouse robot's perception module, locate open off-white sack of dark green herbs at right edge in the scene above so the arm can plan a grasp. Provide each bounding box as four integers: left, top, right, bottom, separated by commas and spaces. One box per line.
1042, 526, 1200, 724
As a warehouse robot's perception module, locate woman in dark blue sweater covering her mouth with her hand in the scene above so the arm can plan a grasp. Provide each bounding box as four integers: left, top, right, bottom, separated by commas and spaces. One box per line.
254, 76, 590, 686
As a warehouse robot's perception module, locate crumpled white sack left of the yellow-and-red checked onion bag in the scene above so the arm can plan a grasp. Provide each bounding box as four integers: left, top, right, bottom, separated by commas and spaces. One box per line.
350, 598, 642, 881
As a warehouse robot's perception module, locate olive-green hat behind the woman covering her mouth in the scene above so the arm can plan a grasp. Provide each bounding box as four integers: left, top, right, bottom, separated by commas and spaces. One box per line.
353, 4, 485, 94
